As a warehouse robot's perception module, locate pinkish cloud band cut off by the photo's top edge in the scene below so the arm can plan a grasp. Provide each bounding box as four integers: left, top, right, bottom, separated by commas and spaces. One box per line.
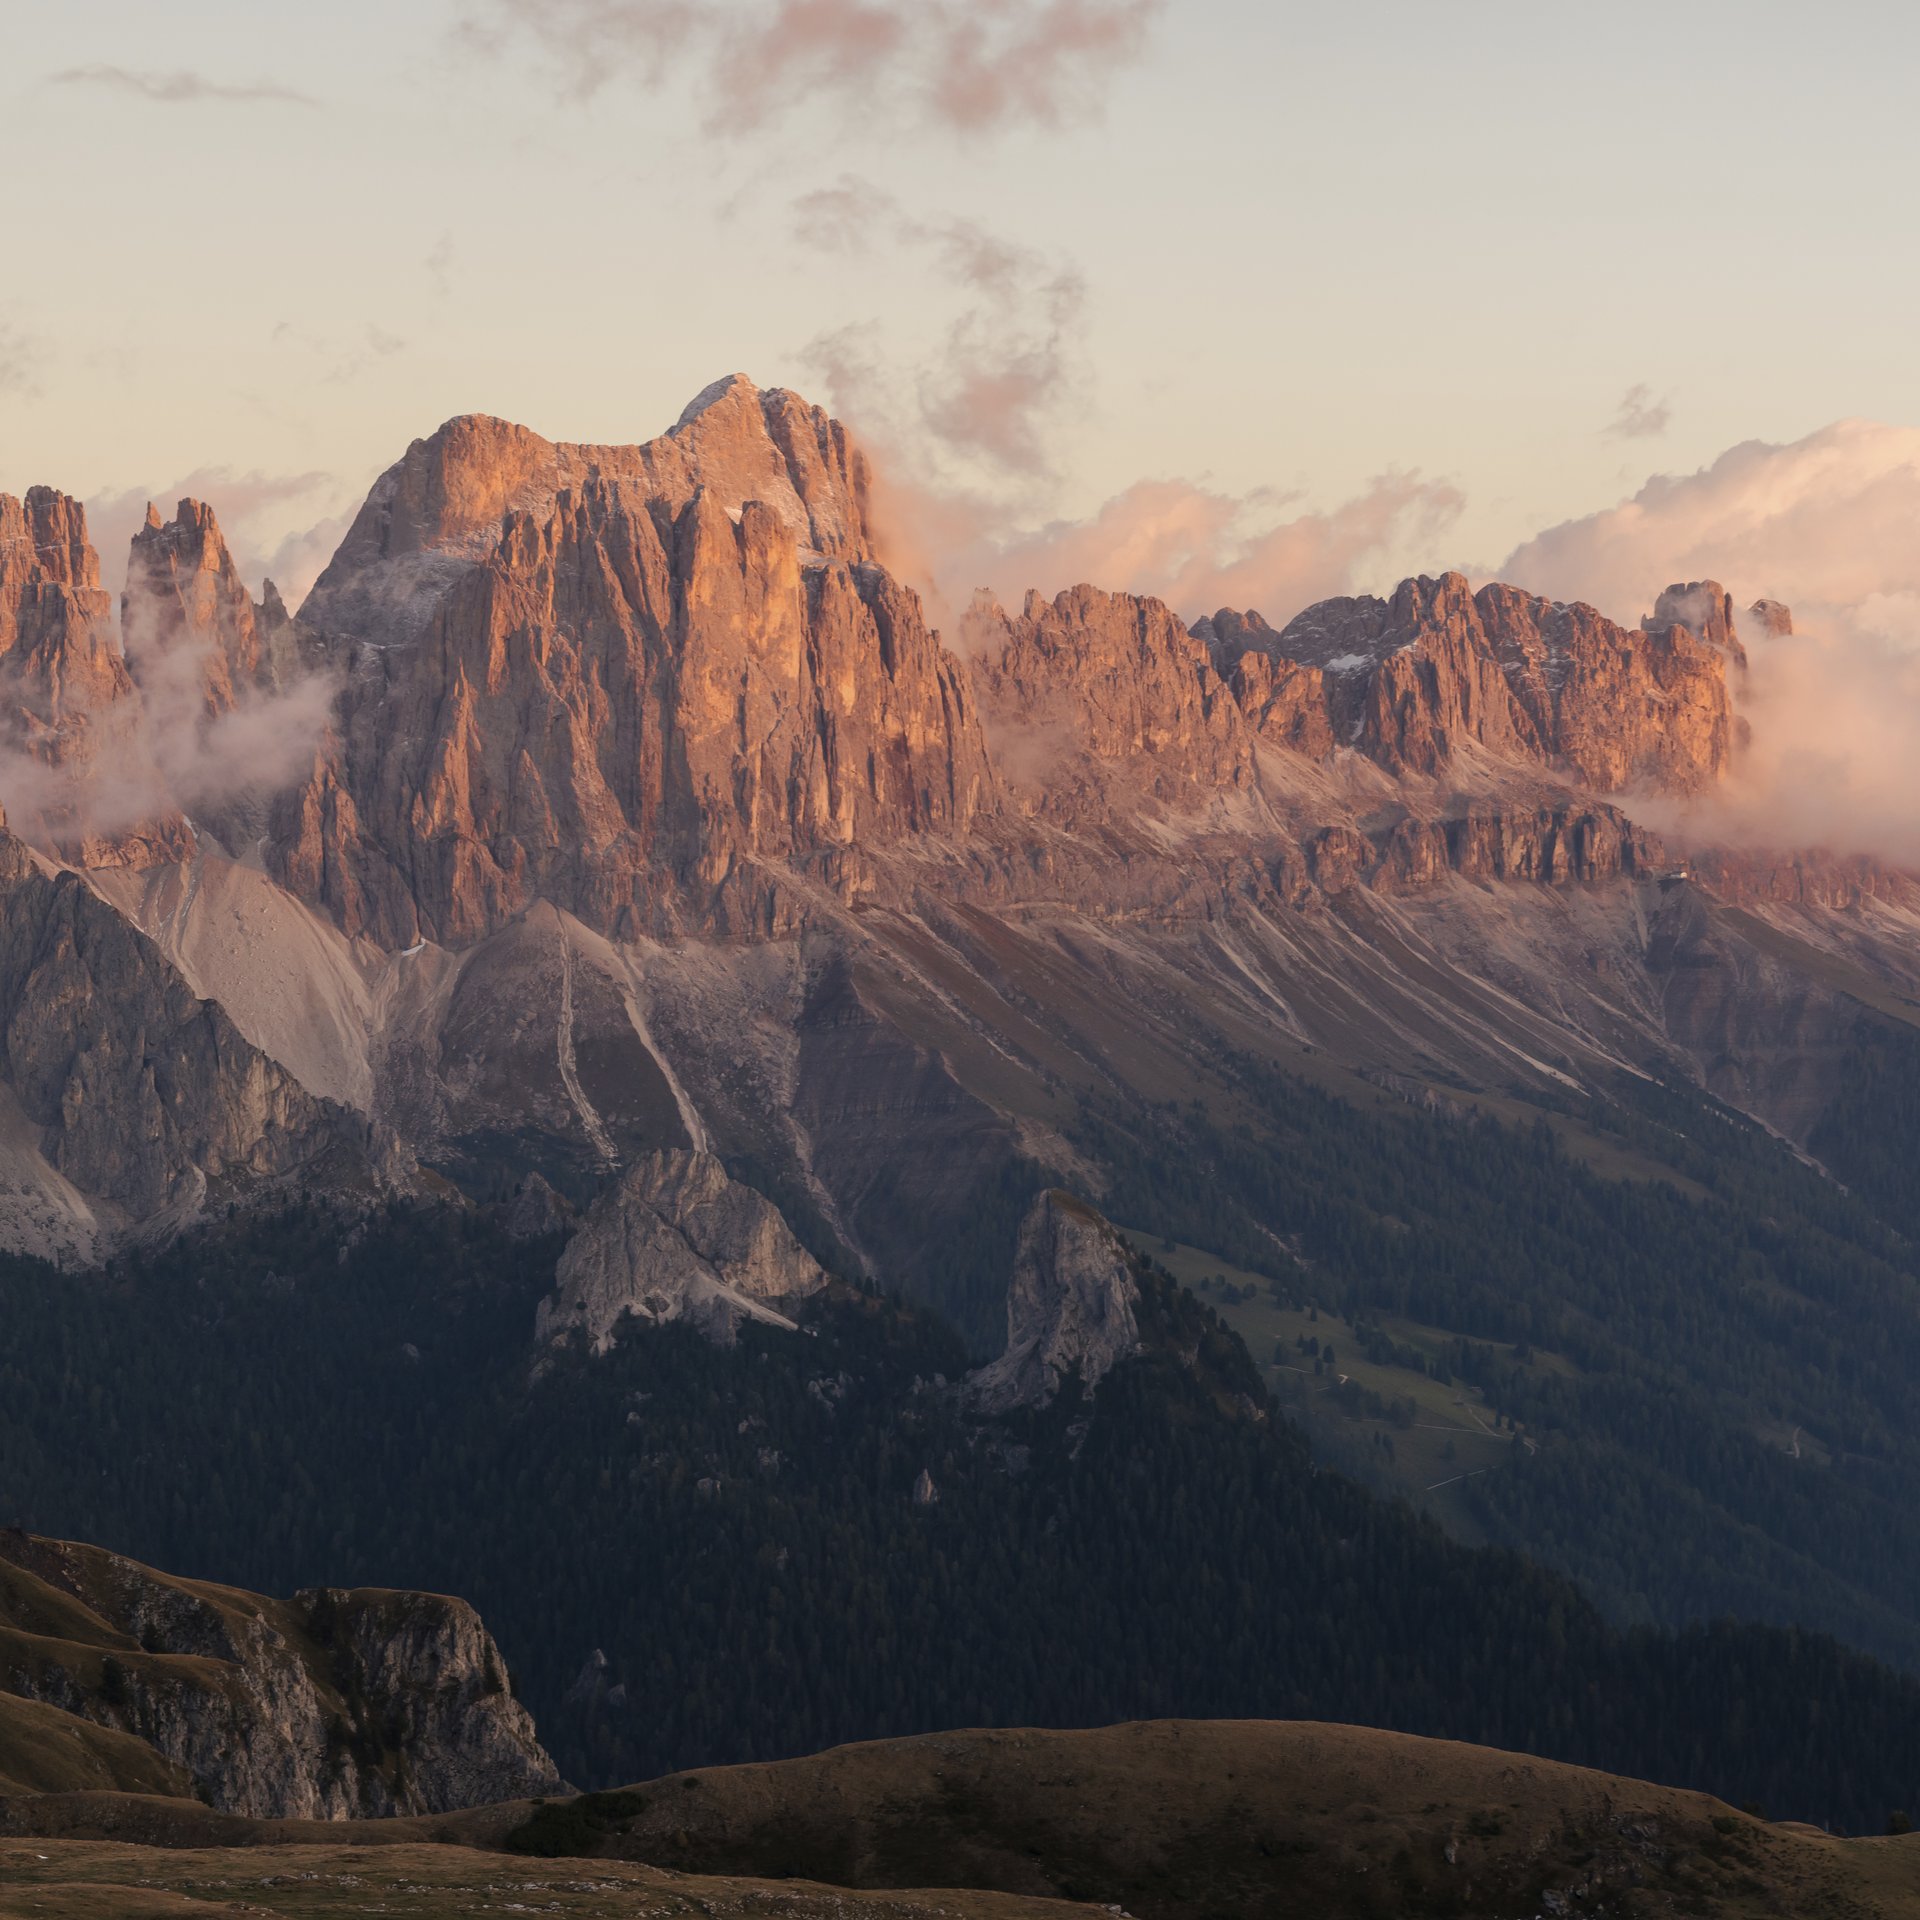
457, 0, 1162, 134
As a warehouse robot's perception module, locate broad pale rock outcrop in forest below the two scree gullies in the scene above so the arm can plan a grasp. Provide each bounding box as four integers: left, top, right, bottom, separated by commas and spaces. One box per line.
534, 1150, 826, 1354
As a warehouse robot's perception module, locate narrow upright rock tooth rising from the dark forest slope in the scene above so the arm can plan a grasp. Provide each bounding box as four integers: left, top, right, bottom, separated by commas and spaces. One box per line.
962, 1190, 1140, 1413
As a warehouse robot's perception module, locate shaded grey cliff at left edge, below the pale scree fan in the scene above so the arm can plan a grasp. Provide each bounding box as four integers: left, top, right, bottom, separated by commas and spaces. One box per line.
0, 829, 353, 1256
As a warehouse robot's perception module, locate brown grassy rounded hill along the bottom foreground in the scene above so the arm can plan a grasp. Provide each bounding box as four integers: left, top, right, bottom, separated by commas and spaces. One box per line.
0, 1720, 1920, 1920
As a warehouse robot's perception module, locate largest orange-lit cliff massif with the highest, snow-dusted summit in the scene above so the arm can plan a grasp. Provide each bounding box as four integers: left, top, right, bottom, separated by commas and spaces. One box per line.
273, 380, 991, 945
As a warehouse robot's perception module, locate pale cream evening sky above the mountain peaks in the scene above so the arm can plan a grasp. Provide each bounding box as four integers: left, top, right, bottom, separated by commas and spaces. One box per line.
0, 0, 1920, 612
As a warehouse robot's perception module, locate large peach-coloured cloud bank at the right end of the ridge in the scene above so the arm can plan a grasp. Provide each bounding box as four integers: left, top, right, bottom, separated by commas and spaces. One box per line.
1500, 420, 1920, 866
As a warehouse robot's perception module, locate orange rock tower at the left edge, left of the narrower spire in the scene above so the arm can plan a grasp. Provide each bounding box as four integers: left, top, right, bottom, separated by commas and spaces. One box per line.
0, 488, 184, 866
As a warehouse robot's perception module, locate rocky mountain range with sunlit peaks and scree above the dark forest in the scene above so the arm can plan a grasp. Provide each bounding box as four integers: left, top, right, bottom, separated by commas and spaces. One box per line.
0, 378, 1920, 1274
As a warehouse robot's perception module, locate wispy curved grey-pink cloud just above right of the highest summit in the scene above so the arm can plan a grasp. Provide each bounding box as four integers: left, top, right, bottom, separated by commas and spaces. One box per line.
791, 175, 1087, 486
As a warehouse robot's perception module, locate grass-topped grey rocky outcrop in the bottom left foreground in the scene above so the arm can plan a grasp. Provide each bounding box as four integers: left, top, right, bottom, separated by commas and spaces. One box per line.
0, 1532, 561, 1820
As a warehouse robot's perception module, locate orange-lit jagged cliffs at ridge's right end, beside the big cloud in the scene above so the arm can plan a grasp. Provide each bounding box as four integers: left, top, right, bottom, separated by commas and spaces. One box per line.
1204, 574, 1745, 793
